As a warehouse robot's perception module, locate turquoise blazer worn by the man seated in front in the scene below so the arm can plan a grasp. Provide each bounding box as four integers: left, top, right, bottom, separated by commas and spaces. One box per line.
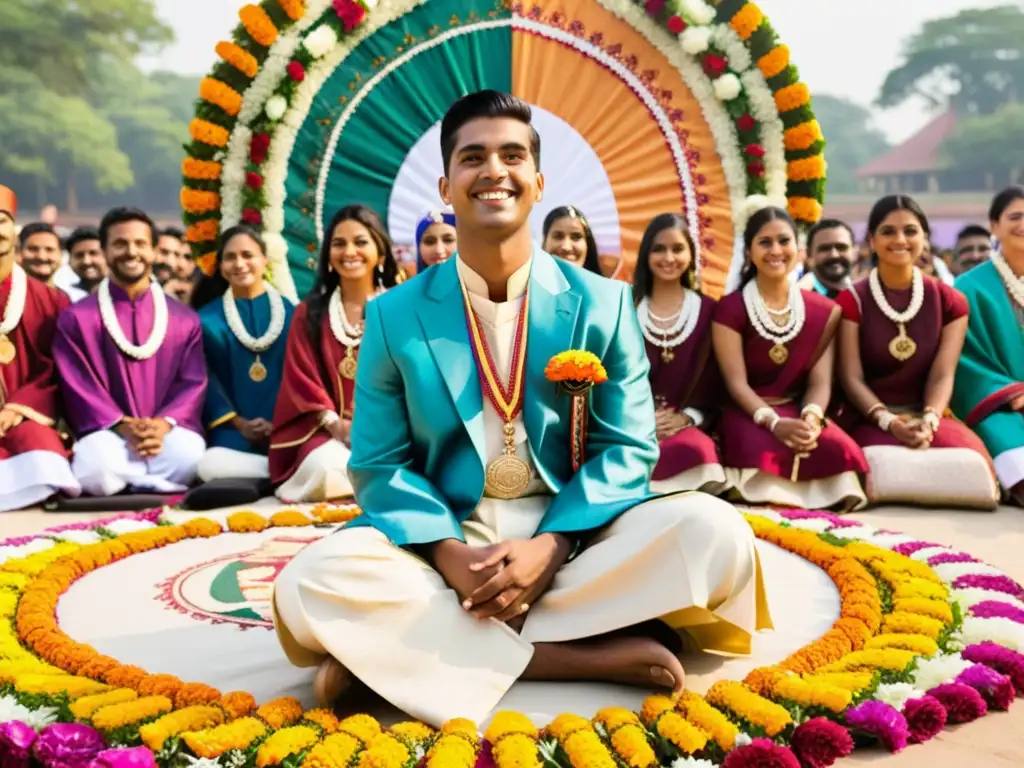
348, 248, 658, 547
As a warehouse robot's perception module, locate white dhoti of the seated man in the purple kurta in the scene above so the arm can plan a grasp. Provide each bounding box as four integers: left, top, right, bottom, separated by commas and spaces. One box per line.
72, 427, 206, 496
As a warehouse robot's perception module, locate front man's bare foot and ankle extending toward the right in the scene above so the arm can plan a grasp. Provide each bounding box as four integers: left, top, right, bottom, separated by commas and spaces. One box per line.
523, 637, 686, 693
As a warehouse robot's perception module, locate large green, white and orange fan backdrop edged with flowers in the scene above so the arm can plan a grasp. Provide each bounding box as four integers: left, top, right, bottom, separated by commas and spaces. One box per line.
182, 0, 825, 298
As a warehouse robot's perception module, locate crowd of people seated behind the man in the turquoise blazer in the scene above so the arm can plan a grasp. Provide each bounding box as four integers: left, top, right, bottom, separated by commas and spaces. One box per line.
0, 181, 1024, 511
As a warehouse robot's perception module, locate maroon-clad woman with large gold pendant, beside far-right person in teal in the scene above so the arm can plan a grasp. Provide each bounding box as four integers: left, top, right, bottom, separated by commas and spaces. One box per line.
837, 195, 998, 509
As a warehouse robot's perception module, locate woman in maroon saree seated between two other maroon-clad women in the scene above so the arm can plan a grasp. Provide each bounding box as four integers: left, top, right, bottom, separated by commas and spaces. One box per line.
712, 208, 867, 510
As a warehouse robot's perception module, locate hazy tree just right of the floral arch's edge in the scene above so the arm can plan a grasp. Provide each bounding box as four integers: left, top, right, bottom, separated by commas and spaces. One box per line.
814, 95, 889, 195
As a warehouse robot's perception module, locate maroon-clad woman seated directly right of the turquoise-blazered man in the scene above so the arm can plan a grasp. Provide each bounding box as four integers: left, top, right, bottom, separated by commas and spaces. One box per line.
633, 213, 727, 494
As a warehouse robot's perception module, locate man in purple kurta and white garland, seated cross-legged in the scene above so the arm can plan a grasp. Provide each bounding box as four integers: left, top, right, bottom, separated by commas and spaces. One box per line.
53, 208, 207, 496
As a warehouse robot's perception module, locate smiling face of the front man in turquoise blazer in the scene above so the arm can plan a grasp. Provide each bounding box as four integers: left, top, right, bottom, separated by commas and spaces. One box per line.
438, 118, 544, 240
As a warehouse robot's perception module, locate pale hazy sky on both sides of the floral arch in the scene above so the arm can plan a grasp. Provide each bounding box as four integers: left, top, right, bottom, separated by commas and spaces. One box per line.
148, 0, 1012, 140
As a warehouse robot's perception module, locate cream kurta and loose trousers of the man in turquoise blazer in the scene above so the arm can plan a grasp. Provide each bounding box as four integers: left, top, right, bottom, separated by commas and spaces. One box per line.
274, 257, 771, 726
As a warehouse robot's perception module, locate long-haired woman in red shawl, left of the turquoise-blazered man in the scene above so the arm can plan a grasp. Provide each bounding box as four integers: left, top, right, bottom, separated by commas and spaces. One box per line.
269, 206, 398, 502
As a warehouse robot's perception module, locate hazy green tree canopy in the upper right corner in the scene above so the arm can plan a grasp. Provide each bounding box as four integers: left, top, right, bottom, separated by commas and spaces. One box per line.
878, 4, 1024, 115
